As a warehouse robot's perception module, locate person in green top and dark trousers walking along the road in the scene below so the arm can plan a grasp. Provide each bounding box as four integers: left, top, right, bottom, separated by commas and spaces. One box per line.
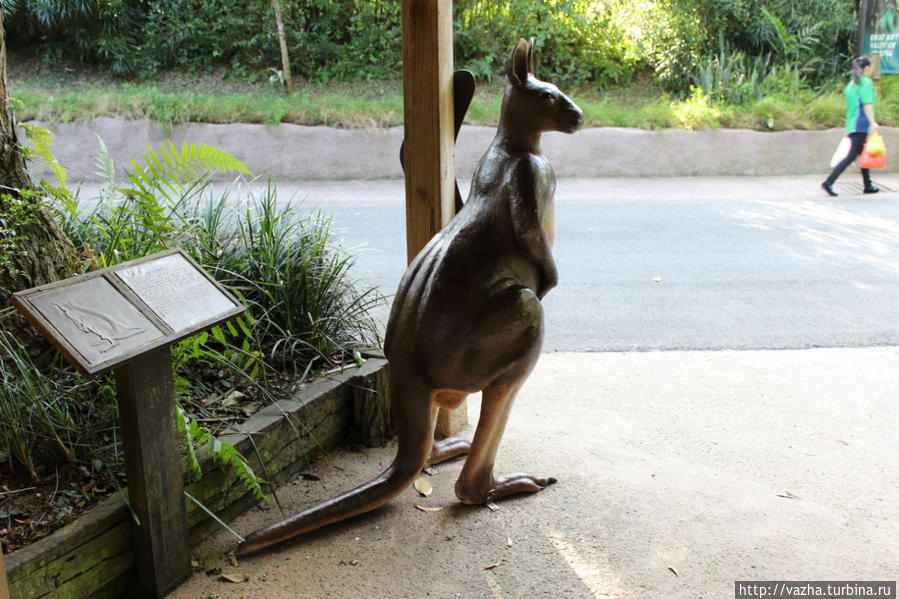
821, 56, 880, 196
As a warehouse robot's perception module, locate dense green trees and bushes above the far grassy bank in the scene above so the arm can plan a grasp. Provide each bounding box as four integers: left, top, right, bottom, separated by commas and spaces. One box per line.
3, 0, 857, 95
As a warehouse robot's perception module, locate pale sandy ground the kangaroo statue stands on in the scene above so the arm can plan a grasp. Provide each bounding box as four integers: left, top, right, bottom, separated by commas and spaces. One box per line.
170, 347, 899, 599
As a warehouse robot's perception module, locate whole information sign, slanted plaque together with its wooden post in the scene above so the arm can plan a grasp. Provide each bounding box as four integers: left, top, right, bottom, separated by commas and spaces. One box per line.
14, 250, 244, 599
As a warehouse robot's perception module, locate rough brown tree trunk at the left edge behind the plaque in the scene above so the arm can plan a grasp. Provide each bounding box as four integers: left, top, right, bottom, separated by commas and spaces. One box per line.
0, 10, 81, 354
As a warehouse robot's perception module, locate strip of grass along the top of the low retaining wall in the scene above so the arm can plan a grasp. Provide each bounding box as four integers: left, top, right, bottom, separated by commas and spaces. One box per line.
17, 72, 899, 130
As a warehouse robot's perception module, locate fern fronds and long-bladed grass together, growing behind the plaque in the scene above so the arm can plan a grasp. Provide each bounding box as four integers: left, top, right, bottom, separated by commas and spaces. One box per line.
63, 142, 384, 372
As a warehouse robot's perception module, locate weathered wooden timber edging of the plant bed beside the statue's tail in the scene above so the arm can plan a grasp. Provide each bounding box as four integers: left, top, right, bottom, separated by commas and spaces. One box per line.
5, 358, 391, 599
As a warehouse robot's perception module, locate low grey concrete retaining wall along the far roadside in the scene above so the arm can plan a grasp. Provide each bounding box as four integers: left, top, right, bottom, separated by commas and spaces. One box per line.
22, 118, 899, 181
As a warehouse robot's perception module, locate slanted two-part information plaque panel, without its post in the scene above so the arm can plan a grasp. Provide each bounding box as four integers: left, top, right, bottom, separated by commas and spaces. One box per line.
11, 250, 244, 376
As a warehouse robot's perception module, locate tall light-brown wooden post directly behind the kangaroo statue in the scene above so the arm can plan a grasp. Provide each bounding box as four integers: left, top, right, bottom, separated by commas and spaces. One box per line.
403, 0, 467, 438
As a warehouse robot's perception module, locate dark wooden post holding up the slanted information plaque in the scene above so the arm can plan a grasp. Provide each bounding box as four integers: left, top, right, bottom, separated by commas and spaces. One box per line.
115, 345, 191, 598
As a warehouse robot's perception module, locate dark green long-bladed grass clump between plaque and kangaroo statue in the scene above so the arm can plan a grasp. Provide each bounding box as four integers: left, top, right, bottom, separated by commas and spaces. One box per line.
190, 181, 384, 373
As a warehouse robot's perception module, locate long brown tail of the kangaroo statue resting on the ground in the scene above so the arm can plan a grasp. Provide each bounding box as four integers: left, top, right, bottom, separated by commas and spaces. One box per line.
237, 367, 435, 555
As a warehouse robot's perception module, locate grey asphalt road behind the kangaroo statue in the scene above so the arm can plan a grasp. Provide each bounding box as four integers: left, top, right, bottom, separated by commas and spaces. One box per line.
279, 173, 899, 351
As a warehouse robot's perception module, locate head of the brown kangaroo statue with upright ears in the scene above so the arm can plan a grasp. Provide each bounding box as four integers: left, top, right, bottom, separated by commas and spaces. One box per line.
499, 39, 584, 152
